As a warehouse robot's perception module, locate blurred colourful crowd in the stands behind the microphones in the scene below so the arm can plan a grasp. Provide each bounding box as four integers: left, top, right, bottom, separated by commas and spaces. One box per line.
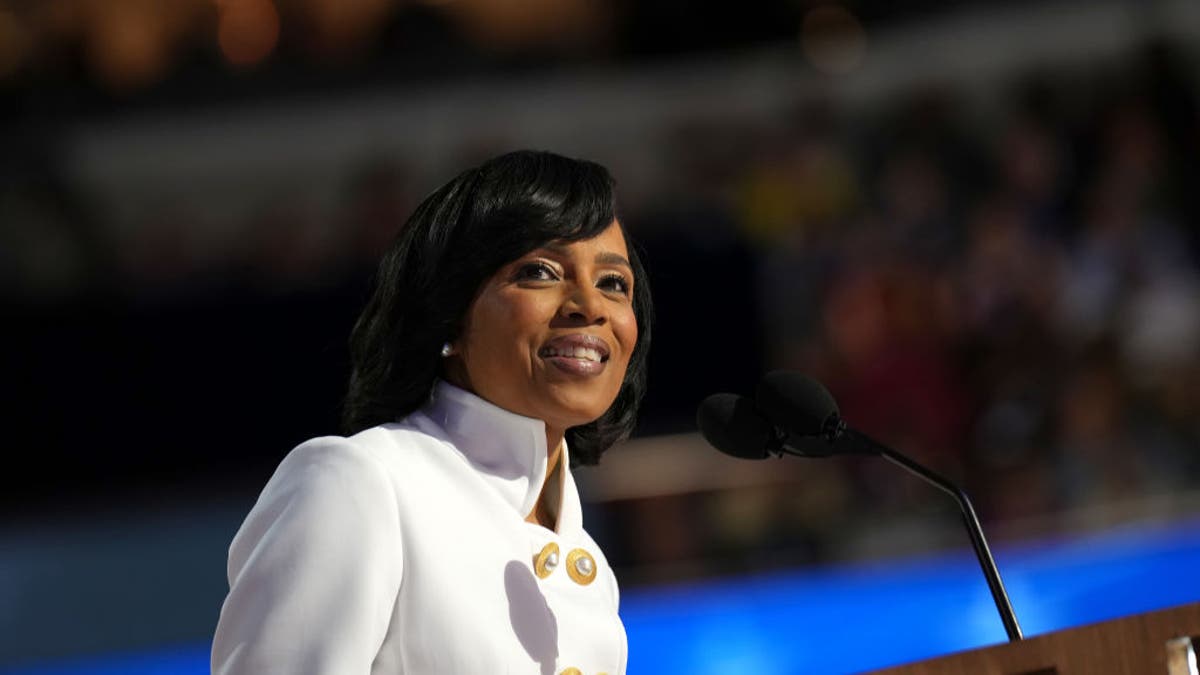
758, 48, 1200, 520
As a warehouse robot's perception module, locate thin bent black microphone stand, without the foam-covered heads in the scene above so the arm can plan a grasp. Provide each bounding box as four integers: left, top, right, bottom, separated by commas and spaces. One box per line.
822, 416, 1022, 643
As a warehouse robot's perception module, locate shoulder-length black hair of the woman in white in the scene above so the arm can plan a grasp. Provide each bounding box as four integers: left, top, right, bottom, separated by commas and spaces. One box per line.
342, 150, 653, 465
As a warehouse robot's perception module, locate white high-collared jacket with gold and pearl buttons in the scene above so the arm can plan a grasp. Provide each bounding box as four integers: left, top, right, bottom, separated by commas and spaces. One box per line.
212, 382, 628, 675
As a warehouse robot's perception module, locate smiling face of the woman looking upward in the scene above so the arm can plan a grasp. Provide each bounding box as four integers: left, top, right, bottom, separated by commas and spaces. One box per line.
446, 220, 637, 432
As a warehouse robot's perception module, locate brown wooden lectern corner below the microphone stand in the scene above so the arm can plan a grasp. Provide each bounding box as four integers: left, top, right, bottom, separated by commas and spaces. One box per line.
871, 603, 1200, 675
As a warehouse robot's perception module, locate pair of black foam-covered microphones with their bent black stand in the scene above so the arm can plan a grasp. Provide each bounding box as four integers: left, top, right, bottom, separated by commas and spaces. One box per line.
696, 370, 1022, 641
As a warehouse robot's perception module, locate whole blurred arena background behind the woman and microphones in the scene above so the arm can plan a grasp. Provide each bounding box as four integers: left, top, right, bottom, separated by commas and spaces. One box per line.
0, 0, 1200, 674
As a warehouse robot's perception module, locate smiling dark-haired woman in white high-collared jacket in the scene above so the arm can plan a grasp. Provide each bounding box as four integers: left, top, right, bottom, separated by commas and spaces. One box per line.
212, 151, 650, 675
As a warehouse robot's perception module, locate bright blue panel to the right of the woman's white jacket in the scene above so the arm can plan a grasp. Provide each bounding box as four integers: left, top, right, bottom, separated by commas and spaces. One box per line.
622, 522, 1200, 675
